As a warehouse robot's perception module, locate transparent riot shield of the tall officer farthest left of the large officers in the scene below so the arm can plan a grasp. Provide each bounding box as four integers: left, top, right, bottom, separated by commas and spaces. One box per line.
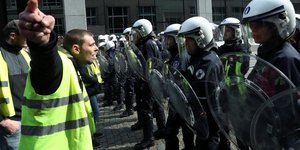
125, 44, 148, 81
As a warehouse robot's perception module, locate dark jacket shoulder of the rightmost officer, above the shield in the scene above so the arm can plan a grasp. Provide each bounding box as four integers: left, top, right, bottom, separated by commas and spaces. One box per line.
257, 42, 300, 87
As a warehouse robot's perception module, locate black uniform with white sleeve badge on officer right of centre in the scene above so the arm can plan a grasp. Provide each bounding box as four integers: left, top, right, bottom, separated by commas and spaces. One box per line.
185, 43, 223, 150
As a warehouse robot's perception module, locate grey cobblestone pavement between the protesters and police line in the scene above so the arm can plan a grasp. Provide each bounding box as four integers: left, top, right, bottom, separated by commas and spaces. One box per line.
95, 94, 182, 150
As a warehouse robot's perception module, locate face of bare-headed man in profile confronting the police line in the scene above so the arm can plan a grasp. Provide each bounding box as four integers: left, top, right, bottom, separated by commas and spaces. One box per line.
72, 34, 99, 64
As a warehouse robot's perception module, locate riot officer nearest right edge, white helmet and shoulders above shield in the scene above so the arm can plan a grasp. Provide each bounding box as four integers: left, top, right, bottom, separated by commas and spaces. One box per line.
242, 0, 300, 86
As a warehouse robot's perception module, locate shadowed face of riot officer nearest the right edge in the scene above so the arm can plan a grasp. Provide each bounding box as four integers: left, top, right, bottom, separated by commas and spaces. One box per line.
250, 21, 273, 44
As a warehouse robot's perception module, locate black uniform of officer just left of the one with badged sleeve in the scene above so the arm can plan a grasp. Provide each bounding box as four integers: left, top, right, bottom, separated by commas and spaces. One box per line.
165, 46, 195, 150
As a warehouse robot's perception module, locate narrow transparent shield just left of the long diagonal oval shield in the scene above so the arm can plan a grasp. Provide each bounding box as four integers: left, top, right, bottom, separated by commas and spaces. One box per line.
148, 58, 167, 106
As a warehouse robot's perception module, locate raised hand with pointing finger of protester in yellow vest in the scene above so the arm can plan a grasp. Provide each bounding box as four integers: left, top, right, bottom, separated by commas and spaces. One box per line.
19, 0, 55, 44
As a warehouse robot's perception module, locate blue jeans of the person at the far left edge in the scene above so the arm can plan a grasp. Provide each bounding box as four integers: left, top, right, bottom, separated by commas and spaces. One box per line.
0, 121, 21, 150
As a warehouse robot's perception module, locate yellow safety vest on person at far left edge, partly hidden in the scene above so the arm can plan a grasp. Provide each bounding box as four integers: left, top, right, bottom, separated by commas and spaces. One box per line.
0, 49, 30, 117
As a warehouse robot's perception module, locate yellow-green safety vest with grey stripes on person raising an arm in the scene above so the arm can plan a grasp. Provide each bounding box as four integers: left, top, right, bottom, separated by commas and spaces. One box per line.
19, 52, 94, 150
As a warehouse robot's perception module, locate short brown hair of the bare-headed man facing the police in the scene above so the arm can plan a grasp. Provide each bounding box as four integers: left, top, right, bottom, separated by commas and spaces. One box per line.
63, 29, 93, 51
